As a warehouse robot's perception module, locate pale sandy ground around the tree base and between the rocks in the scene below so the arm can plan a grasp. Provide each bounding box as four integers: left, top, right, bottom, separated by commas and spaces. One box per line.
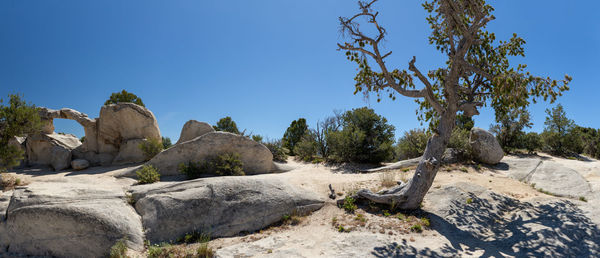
2, 155, 600, 257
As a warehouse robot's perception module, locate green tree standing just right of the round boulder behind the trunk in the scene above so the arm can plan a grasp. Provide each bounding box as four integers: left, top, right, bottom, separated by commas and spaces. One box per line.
490, 107, 533, 152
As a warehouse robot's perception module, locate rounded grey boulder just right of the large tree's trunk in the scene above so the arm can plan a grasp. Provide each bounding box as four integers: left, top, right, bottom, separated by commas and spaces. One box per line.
469, 127, 504, 165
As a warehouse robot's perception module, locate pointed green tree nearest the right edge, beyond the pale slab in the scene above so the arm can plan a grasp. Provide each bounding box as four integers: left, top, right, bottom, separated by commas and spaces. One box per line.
543, 104, 582, 155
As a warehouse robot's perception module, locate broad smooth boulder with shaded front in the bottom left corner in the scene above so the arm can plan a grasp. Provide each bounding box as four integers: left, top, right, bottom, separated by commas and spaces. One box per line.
0, 182, 143, 257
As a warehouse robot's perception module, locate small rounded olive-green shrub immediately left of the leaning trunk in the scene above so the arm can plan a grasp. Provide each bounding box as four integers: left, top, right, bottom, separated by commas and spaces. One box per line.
396, 129, 431, 160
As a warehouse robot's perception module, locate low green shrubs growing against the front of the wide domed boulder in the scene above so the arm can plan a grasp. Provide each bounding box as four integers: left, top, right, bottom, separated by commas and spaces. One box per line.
178, 152, 245, 179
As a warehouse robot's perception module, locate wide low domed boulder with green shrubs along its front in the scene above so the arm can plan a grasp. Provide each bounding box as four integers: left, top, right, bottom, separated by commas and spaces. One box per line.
148, 132, 274, 176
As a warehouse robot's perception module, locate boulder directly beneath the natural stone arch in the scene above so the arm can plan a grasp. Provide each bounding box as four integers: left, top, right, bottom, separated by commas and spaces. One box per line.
26, 133, 81, 171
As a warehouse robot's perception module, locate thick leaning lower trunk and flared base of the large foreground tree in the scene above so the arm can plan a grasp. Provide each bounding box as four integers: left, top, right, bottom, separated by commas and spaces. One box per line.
346, 109, 456, 210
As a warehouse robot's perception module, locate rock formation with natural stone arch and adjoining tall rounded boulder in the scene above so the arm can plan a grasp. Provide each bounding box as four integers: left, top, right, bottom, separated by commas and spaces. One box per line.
26, 103, 161, 170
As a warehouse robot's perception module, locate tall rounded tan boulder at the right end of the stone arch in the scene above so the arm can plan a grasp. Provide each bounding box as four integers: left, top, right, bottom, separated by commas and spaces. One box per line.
98, 103, 161, 154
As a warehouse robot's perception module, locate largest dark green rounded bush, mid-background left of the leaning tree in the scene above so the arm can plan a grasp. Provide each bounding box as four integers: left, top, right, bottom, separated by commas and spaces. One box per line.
328, 107, 394, 163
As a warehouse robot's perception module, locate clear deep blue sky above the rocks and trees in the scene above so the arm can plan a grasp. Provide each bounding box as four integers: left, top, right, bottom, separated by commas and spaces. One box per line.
0, 0, 600, 140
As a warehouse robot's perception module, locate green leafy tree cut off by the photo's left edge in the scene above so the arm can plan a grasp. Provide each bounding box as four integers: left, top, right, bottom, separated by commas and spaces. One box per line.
0, 95, 42, 171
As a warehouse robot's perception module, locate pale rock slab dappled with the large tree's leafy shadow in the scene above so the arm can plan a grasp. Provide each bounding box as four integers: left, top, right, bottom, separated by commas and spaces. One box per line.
422, 183, 600, 257
